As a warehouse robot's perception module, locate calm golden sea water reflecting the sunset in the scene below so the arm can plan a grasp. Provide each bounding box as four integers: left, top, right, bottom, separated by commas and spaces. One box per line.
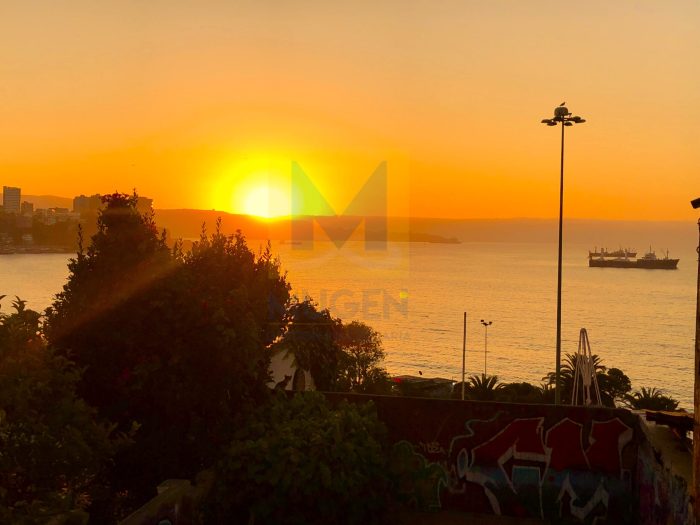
0, 242, 697, 408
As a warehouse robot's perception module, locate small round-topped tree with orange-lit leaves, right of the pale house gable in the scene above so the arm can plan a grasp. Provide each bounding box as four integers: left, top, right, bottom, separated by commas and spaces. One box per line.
337, 321, 391, 394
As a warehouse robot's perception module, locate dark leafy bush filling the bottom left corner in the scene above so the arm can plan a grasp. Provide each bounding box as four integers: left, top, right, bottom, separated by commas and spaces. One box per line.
0, 297, 113, 524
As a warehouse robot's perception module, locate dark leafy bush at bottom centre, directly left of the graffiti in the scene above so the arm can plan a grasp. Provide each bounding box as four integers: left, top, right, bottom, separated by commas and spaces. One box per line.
204, 392, 387, 525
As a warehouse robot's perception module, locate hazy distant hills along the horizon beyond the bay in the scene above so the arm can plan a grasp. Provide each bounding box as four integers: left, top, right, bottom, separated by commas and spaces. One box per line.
15, 195, 697, 251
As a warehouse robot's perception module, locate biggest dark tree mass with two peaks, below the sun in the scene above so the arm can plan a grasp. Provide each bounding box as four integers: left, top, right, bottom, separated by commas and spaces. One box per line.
45, 194, 289, 516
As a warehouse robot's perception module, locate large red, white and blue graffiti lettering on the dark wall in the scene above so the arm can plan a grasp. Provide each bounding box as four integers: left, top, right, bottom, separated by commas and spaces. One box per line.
450, 416, 633, 522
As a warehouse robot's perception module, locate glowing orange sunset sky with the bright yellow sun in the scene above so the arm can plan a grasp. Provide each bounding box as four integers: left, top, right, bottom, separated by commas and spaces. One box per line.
0, 0, 700, 220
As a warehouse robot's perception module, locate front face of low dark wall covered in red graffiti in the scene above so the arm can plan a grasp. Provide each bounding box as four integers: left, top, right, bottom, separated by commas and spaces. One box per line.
330, 397, 642, 524
